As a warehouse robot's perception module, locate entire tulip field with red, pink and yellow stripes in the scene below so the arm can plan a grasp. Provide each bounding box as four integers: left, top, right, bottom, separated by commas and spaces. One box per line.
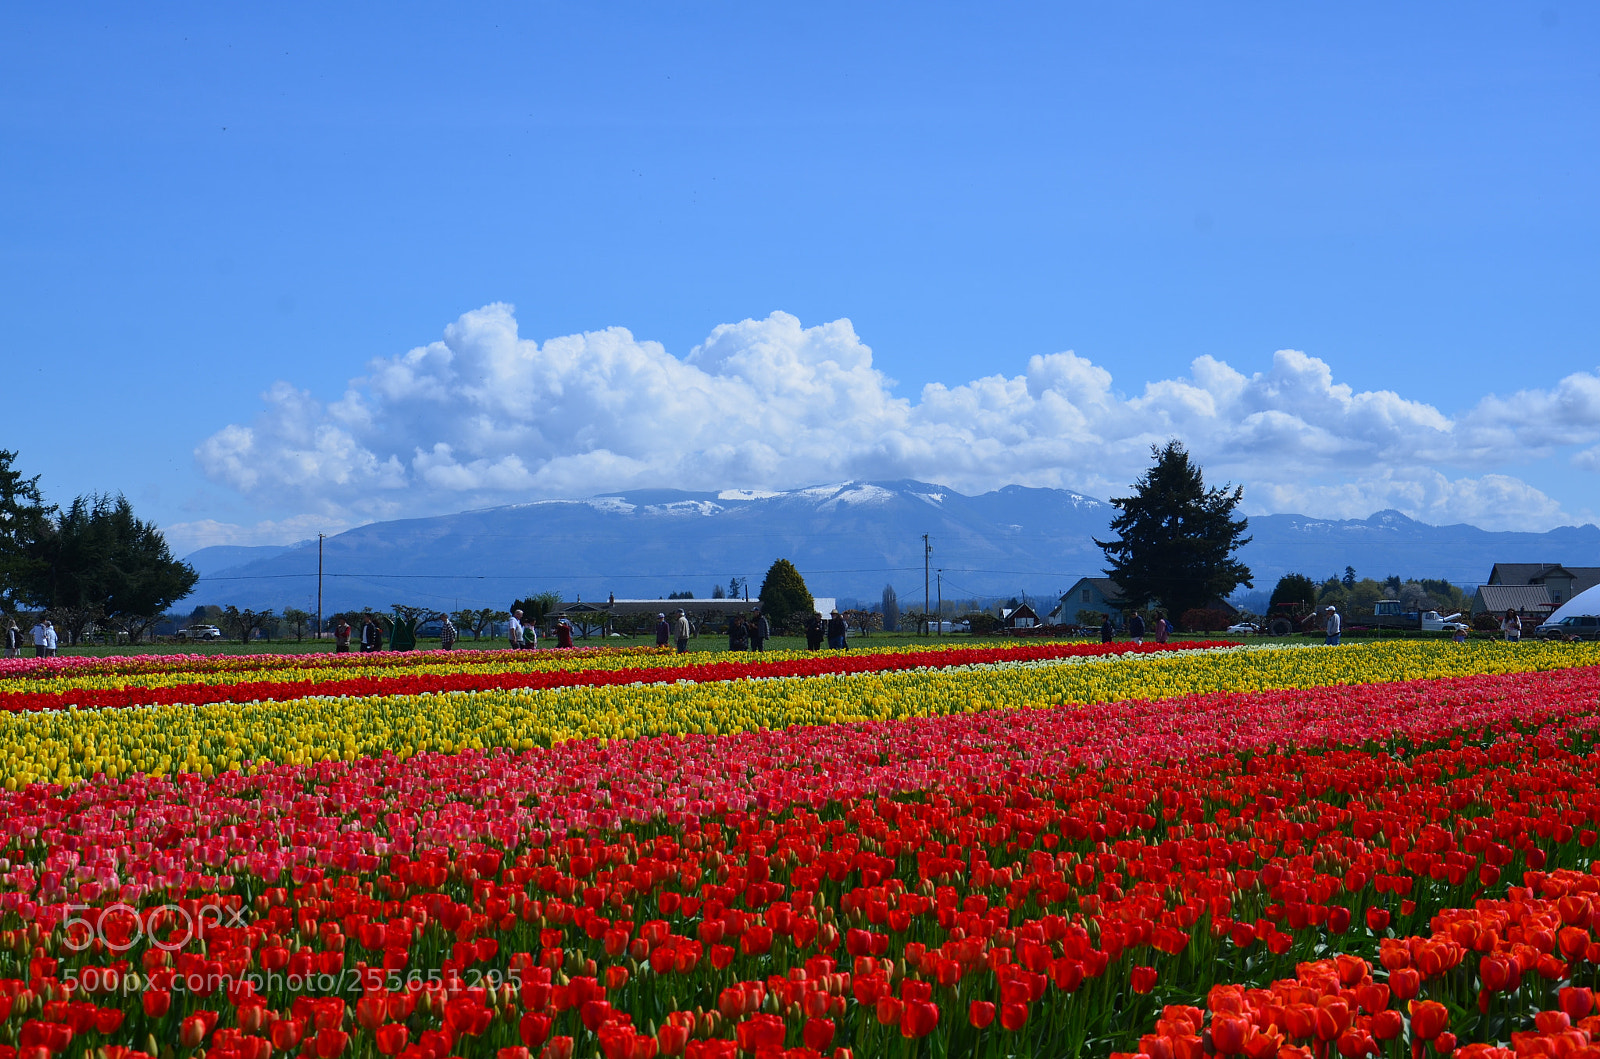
0, 641, 1600, 1059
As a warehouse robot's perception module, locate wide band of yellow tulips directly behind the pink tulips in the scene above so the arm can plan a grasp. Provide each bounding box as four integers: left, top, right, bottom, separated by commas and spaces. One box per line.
0, 641, 1600, 789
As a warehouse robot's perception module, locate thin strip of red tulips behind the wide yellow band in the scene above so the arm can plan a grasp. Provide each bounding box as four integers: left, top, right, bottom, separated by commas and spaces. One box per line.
0, 640, 1227, 713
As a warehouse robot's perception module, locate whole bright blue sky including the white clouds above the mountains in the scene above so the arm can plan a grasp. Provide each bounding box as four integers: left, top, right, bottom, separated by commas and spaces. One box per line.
0, 3, 1600, 550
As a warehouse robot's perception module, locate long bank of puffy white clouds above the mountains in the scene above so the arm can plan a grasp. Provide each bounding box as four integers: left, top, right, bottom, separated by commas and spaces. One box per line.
195, 304, 1600, 540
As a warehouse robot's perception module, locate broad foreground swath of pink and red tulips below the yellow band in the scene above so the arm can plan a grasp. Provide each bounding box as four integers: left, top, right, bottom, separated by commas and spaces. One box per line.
0, 670, 1600, 1059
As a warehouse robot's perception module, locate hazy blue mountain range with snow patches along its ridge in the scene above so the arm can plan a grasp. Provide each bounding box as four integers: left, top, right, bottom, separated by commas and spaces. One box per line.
181, 480, 1600, 614
